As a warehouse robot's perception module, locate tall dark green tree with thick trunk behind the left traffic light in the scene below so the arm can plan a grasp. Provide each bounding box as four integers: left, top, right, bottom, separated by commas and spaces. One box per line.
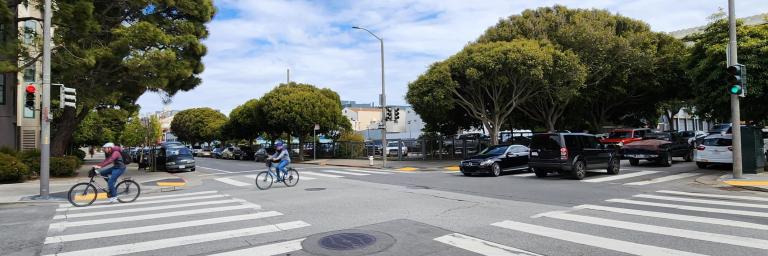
51, 0, 215, 156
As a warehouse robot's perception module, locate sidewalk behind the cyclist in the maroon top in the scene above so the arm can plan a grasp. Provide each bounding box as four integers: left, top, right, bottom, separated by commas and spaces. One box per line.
0, 158, 179, 204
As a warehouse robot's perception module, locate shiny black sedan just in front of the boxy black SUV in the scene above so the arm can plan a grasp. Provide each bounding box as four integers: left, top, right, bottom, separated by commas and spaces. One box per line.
459, 145, 529, 177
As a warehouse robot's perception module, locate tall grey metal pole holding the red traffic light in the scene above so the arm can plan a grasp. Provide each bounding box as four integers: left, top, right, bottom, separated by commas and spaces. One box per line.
40, 0, 53, 200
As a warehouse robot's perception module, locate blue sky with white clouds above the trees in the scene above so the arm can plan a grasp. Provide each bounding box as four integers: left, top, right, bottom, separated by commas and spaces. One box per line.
138, 0, 768, 115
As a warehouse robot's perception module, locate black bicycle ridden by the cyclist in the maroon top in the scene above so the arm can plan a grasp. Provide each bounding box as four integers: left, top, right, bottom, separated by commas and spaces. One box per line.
67, 168, 141, 207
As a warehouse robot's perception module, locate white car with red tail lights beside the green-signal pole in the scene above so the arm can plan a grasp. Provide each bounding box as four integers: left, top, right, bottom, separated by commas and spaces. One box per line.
693, 134, 733, 169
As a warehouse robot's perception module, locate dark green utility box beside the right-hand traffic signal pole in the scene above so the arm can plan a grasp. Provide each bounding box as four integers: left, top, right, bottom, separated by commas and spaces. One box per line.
741, 126, 765, 174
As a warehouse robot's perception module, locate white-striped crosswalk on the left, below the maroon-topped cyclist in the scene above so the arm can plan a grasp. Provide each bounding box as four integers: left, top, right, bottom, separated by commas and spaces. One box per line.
41, 191, 310, 256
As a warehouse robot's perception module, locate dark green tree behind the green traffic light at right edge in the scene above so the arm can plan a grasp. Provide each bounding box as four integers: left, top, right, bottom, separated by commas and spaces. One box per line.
684, 19, 768, 123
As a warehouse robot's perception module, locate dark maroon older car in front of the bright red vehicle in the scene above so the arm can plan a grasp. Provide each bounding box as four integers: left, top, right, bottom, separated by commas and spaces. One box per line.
621, 132, 693, 166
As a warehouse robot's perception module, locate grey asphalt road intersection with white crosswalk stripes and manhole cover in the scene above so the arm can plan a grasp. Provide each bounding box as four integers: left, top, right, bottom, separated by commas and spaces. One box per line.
0, 156, 768, 256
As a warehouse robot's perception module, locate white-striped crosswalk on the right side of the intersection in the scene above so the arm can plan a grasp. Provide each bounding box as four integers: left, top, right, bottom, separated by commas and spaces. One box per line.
435, 190, 768, 255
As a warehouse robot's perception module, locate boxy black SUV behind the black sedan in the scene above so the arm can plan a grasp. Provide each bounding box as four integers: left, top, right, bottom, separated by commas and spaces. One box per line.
528, 133, 620, 180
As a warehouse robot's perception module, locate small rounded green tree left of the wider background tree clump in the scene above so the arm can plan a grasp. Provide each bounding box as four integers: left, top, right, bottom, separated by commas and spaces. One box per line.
171, 108, 227, 144
